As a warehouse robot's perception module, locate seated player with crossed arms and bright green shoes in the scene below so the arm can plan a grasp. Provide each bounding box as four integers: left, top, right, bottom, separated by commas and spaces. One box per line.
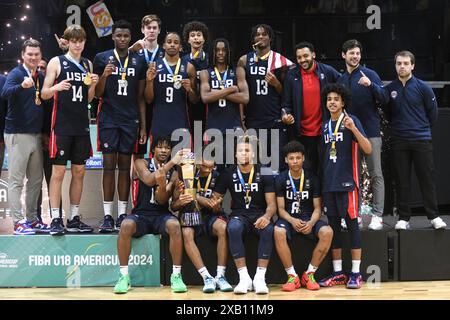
114, 138, 187, 293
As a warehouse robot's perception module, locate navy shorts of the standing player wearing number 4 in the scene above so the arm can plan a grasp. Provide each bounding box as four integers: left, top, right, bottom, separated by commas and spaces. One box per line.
322, 188, 359, 219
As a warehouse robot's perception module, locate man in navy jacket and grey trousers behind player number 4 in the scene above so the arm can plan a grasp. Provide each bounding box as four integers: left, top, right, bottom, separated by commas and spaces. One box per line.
338, 39, 389, 230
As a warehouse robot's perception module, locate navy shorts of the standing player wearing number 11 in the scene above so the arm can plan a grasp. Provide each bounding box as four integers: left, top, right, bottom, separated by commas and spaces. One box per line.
97, 123, 139, 155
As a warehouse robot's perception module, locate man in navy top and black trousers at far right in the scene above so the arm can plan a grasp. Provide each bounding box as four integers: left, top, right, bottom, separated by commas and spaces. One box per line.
386, 51, 447, 229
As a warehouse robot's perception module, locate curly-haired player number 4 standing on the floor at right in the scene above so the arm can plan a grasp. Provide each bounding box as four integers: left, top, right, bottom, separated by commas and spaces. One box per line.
319, 84, 372, 289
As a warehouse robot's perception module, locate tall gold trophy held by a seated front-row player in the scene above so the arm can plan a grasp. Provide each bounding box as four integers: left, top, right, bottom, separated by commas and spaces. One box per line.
180, 152, 202, 227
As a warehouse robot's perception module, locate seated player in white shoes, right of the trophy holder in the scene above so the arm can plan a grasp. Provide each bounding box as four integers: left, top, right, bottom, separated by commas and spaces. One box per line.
214, 136, 277, 294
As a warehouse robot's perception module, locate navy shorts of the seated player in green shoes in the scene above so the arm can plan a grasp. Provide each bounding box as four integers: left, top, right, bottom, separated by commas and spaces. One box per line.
125, 212, 178, 238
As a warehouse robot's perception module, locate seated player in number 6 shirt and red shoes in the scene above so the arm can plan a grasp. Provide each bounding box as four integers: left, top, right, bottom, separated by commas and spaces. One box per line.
274, 141, 333, 291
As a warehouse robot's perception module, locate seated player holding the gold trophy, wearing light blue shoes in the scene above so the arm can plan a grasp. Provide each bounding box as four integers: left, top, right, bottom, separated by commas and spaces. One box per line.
172, 154, 233, 293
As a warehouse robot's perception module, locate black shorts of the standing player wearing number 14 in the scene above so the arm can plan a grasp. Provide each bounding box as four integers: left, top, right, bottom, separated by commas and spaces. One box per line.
50, 134, 92, 166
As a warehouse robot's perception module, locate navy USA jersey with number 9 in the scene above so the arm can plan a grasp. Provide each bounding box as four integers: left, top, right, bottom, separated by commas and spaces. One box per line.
151, 59, 189, 136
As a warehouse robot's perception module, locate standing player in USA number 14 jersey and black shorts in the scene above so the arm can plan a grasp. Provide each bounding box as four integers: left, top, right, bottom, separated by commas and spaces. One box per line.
42, 25, 98, 235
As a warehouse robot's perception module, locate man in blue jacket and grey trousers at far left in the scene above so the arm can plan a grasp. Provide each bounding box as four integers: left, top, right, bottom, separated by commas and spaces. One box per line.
2, 39, 49, 235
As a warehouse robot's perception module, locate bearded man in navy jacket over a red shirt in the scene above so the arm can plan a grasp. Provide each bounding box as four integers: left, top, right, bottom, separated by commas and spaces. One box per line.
282, 42, 340, 175
